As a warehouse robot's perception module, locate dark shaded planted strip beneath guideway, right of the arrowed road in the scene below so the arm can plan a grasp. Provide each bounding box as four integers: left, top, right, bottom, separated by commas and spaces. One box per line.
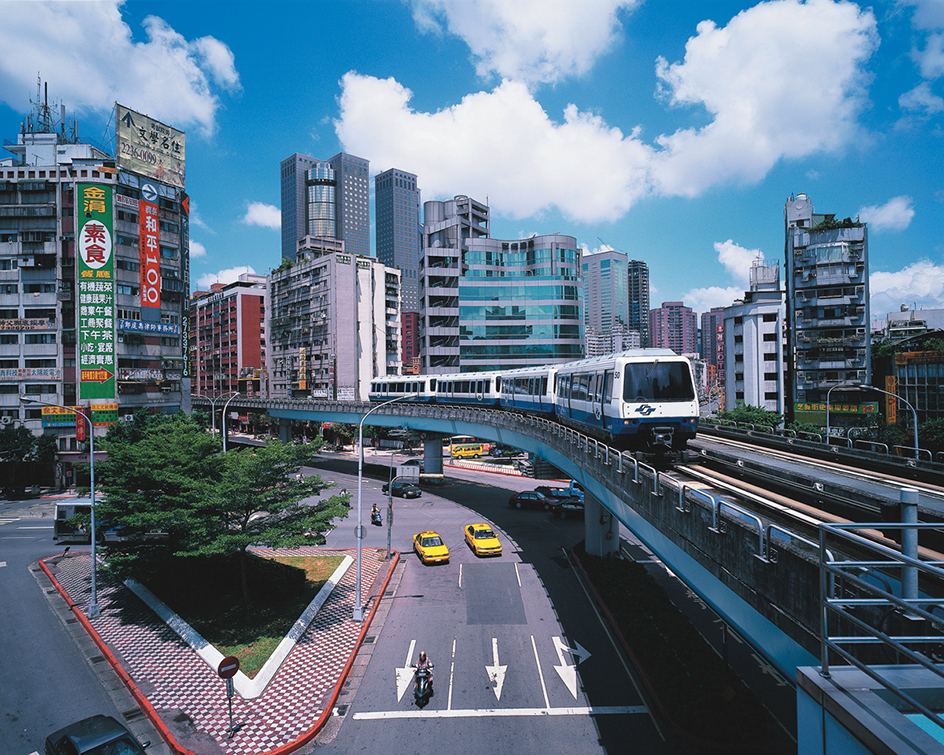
575, 544, 772, 752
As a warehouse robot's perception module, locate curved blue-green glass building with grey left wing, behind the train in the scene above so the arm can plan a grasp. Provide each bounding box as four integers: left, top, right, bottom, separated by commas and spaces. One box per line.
420, 197, 584, 373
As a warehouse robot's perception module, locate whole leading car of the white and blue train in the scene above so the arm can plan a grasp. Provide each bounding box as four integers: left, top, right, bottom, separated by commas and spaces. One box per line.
555, 349, 698, 454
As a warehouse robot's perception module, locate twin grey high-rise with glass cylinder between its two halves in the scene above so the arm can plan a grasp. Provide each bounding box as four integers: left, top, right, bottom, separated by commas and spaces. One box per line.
281, 152, 370, 260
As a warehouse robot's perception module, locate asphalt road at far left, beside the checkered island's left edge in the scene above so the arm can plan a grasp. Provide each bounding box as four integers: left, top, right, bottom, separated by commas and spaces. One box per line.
0, 499, 168, 755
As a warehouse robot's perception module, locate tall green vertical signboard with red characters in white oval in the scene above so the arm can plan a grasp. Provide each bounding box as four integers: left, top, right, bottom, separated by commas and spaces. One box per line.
76, 184, 115, 400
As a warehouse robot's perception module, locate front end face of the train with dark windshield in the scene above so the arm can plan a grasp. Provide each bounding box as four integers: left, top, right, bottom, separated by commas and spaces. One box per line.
613, 349, 698, 453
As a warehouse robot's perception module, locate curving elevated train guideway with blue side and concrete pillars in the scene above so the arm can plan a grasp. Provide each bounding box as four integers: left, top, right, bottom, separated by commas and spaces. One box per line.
194, 398, 944, 683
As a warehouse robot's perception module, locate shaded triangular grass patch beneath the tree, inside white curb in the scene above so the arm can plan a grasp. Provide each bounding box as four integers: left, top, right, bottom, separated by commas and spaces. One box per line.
146, 553, 343, 677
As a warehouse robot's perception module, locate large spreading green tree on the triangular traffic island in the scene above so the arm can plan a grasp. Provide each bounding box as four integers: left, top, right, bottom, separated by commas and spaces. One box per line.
95, 413, 347, 605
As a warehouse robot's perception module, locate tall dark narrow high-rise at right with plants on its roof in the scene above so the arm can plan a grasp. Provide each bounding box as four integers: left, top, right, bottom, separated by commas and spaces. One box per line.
783, 194, 872, 427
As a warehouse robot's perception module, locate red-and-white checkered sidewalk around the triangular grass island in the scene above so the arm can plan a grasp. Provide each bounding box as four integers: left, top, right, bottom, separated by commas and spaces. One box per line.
41, 548, 397, 755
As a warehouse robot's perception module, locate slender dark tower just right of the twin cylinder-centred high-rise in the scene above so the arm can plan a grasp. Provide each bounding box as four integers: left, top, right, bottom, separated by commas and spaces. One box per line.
374, 168, 423, 372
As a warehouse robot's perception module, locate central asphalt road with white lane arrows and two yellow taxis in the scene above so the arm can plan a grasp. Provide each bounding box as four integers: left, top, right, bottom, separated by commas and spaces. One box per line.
308, 457, 691, 755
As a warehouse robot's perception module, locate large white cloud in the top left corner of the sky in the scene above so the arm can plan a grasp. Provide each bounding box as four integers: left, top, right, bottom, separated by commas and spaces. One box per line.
0, 0, 239, 133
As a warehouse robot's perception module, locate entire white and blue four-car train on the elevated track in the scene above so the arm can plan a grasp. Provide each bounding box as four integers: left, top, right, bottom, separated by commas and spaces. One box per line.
370, 349, 698, 453
